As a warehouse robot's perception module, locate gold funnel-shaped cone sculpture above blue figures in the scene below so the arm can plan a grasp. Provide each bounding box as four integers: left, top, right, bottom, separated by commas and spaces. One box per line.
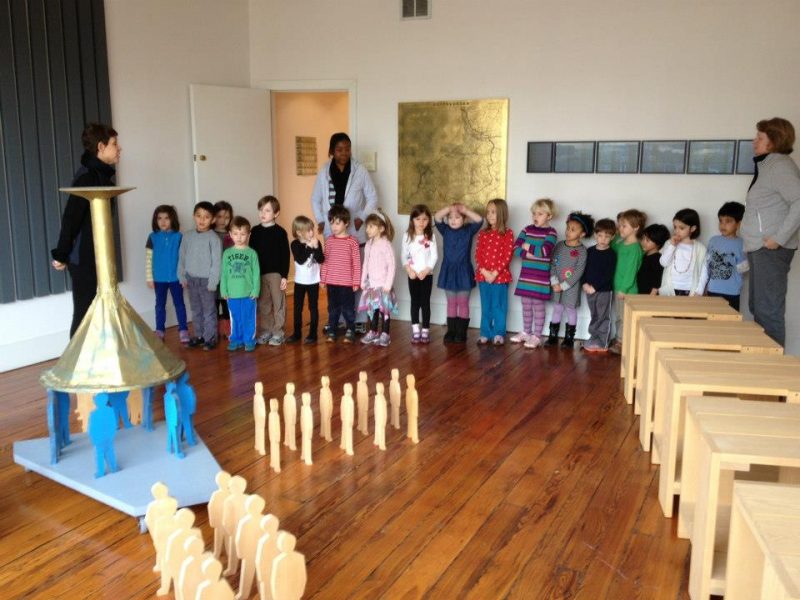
39, 187, 186, 393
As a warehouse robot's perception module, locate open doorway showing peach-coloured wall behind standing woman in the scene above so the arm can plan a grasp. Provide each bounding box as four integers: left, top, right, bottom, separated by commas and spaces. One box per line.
271, 91, 350, 281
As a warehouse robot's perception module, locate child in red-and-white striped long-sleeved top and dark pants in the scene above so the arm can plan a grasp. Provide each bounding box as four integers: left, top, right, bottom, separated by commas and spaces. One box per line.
320, 204, 361, 344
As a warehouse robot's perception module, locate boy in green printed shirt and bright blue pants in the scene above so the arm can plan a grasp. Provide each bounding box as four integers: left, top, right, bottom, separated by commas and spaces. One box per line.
219, 217, 261, 352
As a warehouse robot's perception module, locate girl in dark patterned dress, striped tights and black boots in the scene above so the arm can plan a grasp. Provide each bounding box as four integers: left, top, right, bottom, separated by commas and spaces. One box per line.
544, 212, 594, 348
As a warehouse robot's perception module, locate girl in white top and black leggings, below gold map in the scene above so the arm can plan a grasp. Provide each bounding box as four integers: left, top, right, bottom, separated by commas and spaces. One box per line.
402, 204, 439, 344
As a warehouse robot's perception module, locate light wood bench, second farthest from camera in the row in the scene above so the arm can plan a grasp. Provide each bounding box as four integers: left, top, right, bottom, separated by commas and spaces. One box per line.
633, 317, 783, 450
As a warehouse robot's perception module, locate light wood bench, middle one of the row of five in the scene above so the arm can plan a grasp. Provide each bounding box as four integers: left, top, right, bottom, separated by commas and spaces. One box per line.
650, 349, 800, 517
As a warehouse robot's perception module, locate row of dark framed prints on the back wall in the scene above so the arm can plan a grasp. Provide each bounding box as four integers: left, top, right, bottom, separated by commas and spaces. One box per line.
528, 139, 754, 175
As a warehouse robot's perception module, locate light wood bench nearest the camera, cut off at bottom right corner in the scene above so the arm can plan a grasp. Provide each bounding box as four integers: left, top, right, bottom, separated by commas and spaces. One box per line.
725, 481, 800, 600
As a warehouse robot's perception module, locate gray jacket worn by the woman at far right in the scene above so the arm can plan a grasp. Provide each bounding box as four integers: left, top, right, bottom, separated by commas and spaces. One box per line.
740, 153, 800, 252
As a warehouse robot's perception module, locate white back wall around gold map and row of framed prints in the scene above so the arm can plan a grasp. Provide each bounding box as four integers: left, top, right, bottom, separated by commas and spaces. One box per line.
250, 0, 800, 353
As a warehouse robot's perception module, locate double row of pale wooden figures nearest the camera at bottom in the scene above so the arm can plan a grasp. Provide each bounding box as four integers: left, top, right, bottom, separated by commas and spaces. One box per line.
145, 471, 306, 600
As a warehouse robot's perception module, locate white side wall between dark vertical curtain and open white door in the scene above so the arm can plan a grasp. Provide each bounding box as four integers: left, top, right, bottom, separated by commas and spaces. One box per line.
0, 0, 249, 371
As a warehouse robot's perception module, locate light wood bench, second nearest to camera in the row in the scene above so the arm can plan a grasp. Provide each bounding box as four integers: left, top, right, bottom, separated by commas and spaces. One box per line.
678, 397, 800, 600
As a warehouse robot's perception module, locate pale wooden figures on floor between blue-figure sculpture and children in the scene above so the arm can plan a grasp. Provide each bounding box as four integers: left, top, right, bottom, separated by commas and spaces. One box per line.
253, 369, 419, 473
